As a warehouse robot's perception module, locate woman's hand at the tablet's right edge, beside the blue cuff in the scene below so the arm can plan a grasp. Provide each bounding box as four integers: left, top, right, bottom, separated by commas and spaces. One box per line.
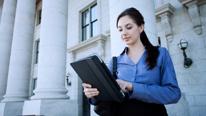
116, 79, 133, 92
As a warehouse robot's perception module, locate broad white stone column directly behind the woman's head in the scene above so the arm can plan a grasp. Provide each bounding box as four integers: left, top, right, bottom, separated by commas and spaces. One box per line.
109, 0, 157, 55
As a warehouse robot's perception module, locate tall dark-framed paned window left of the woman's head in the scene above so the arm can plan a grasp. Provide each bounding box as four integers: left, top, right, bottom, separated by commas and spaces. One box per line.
82, 4, 99, 41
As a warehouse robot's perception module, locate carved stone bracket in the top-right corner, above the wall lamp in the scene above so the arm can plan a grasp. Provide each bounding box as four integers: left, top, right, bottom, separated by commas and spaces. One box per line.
179, 0, 203, 35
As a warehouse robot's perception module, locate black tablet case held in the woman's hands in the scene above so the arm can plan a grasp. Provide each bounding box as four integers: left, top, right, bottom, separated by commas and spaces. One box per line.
71, 55, 125, 102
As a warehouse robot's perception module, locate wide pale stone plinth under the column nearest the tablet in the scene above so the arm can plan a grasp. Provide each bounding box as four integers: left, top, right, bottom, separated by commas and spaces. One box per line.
23, 99, 80, 116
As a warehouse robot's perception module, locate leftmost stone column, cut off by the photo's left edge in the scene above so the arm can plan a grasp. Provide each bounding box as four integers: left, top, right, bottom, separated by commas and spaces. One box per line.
0, 0, 16, 100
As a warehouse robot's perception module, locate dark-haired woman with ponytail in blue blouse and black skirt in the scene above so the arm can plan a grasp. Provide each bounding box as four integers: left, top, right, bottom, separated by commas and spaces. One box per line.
82, 8, 181, 116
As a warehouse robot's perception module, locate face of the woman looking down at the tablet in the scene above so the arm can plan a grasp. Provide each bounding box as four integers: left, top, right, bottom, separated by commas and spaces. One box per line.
117, 15, 144, 46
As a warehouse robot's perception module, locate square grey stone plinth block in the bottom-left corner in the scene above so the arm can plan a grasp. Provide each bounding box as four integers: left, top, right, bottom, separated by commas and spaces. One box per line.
0, 102, 24, 116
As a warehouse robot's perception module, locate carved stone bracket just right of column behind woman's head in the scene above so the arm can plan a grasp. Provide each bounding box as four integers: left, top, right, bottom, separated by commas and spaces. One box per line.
155, 3, 175, 42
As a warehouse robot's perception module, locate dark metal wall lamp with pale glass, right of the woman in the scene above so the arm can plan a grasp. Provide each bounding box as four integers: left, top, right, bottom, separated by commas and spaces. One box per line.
178, 39, 192, 68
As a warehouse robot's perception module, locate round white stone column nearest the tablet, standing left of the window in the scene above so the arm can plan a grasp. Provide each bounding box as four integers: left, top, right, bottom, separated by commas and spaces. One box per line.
32, 0, 68, 99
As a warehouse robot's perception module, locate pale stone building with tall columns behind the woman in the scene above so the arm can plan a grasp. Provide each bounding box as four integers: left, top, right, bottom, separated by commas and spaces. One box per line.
0, 0, 206, 116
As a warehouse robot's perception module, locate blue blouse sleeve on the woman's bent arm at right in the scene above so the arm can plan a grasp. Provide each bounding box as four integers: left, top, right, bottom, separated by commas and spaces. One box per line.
130, 48, 181, 104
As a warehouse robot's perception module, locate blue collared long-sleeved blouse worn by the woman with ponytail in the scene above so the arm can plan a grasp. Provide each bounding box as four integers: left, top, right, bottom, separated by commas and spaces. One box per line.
108, 47, 181, 104
